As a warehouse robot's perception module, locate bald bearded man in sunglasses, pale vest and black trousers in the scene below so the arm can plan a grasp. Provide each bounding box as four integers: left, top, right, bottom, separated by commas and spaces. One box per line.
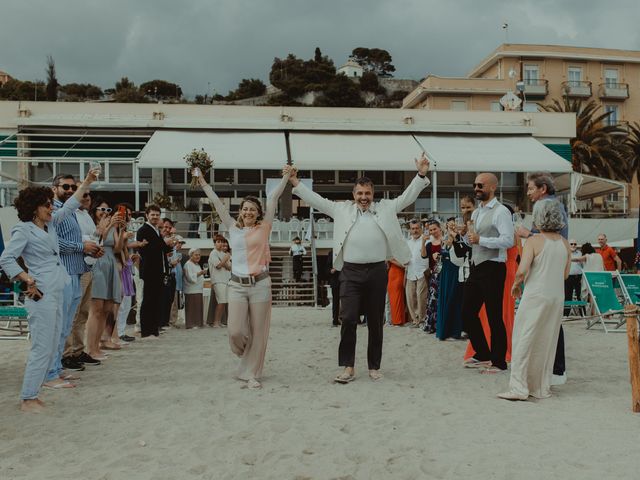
462, 173, 514, 373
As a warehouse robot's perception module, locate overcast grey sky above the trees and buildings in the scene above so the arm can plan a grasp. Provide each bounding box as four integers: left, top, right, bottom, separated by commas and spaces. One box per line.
0, 0, 640, 96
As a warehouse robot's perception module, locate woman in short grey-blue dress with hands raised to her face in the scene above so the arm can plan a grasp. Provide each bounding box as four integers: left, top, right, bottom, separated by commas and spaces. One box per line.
87, 198, 127, 361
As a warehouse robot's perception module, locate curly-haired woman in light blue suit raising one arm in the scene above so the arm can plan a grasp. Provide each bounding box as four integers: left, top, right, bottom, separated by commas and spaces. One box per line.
0, 170, 98, 413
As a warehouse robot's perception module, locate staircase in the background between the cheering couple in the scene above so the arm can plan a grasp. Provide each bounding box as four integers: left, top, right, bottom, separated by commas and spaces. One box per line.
269, 245, 315, 307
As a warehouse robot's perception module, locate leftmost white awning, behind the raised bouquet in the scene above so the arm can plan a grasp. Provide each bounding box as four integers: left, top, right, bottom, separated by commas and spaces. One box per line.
138, 130, 287, 170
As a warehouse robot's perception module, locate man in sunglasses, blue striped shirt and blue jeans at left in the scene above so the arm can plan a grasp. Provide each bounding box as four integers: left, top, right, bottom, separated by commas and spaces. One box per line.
45, 174, 100, 388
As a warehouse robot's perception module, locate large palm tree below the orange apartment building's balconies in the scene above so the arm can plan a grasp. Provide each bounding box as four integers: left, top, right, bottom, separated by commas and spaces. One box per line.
540, 95, 640, 182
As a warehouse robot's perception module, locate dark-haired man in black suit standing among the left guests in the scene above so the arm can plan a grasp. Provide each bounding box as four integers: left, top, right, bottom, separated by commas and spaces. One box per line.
136, 205, 171, 338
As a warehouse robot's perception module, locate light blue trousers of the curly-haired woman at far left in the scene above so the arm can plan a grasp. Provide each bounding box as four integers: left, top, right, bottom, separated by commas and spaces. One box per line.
20, 290, 63, 400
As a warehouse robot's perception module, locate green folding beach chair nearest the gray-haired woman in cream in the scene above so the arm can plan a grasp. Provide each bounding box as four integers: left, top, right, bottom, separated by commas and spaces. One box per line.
582, 272, 625, 333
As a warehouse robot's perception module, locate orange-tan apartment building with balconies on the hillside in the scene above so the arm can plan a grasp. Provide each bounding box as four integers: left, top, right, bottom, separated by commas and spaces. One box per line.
403, 44, 640, 127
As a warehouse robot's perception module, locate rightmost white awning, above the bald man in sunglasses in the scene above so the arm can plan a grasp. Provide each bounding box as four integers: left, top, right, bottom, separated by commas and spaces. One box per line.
416, 135, 571, 173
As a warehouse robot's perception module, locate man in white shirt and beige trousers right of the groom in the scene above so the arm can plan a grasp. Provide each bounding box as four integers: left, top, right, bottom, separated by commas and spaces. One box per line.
405, 218, 429, 327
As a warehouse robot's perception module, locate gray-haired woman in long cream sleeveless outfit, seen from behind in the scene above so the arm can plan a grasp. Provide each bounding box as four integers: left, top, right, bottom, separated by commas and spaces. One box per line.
498, 200, 571, 400
